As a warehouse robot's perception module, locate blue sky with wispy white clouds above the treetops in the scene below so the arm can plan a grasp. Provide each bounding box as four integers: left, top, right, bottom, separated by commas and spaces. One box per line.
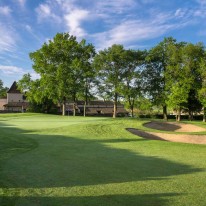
0, 0, 206, 87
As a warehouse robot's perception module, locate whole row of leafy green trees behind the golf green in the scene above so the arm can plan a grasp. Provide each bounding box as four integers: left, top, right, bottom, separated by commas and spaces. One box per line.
18, 33, 206, 121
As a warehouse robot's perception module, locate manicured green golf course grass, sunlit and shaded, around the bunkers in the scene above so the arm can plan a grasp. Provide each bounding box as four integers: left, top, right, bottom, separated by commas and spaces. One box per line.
0, 114, 206, 206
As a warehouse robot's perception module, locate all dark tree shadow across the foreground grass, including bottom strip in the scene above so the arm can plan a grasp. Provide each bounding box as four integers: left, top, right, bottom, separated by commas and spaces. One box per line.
0, 123, 203, 205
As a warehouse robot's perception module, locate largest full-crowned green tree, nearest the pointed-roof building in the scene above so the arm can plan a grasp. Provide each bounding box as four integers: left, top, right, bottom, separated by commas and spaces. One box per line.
30, 33, 94, 115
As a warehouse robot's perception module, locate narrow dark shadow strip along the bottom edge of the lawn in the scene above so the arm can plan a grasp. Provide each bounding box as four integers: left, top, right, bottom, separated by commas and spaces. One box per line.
0, 193, 179, 206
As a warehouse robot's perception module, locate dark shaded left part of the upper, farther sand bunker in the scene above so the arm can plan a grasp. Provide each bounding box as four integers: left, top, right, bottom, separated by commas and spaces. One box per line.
143, 121, 181, 131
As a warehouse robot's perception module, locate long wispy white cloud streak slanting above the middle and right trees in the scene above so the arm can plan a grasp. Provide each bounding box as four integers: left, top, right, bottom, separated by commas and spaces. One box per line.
92, 10, 191, 49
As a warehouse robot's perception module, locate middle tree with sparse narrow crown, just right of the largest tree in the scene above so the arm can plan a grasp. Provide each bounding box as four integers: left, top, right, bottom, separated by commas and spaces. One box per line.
94, 44, 126, 118
